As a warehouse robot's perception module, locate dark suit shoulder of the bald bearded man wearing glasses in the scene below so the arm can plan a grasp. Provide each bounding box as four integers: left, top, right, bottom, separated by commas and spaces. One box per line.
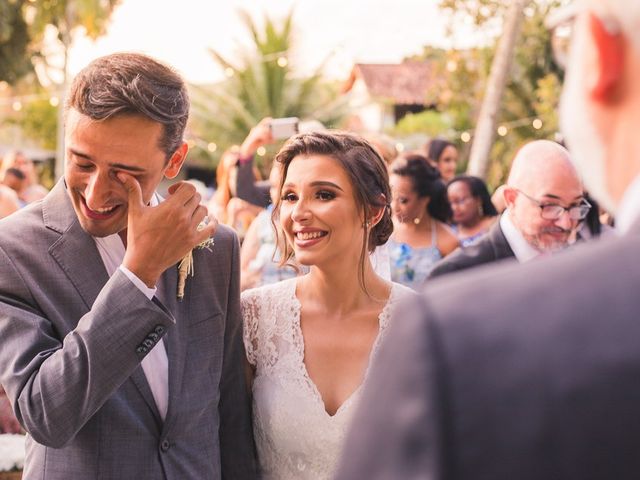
429, 220, 515, 278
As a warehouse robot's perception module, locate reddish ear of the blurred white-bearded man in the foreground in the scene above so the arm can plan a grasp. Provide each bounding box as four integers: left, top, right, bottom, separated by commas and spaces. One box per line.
589, 13, 624, 101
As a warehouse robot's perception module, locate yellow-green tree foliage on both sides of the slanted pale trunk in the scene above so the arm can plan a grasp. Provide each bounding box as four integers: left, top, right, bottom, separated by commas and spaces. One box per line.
440, 0, 566, 187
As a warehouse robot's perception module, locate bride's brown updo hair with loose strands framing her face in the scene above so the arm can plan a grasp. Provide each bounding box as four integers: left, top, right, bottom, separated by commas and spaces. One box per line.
273, 131, 393, 284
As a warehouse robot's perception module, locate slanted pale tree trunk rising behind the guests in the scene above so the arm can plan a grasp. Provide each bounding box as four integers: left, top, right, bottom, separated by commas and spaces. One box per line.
467, 0, 531, 179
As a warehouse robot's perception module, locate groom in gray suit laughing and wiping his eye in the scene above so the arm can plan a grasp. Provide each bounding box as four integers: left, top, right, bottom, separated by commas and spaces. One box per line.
0, 54, 255, 480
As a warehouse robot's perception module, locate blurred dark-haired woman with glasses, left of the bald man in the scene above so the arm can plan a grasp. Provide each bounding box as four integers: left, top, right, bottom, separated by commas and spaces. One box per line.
447, 175, 498, 247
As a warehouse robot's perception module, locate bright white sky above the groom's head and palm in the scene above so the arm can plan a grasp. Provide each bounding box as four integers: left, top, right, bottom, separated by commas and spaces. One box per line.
69, 0, 484, 83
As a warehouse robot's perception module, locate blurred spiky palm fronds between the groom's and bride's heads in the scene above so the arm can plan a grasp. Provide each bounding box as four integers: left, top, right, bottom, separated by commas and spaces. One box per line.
191, 12, 344, 167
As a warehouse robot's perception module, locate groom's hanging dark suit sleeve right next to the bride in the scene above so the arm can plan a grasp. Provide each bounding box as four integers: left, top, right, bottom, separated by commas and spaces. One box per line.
219, 235, 256, 480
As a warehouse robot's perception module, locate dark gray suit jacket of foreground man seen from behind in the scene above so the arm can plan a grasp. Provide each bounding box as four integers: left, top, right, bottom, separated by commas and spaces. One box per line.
337, 225, 640, 480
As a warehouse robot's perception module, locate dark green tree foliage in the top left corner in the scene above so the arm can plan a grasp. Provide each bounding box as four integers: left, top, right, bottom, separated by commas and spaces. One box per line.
0, 0, 32, 85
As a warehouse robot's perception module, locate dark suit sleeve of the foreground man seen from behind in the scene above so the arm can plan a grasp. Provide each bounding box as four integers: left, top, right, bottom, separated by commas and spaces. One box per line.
336, 297, 445, 480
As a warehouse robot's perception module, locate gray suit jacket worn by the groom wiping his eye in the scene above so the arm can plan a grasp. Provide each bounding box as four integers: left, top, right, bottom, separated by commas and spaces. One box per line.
0, 181, 255, 480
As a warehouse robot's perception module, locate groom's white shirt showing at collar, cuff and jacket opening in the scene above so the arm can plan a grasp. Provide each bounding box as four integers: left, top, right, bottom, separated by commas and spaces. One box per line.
93, 195, 169, 420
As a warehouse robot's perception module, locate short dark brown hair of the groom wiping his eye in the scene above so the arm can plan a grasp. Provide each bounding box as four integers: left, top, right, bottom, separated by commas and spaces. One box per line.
65, 53, 189, 159
